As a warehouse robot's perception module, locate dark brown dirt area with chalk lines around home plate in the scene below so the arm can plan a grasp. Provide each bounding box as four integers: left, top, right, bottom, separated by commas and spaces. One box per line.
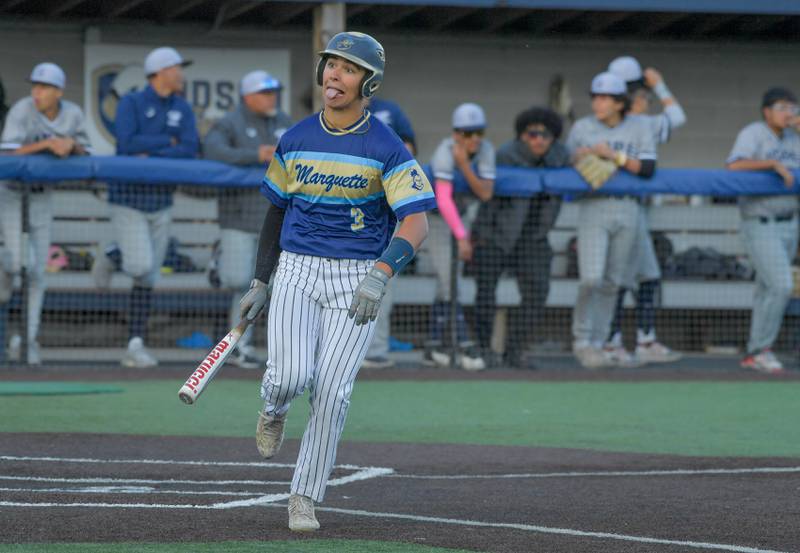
0, 434, 800, 553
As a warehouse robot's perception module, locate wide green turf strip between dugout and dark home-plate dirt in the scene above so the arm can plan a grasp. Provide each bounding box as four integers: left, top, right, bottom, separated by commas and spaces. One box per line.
0, 377, 800, 457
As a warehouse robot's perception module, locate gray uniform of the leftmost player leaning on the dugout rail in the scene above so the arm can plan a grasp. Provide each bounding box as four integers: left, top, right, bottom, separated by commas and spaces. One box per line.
0, 96, 91, 340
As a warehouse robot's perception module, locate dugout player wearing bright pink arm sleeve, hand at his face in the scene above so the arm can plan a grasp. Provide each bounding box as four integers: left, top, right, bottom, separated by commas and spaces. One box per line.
426, 103, 496, 371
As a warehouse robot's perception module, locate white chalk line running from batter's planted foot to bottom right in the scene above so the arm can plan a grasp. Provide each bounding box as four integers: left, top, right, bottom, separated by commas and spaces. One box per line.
292, 505, 789, 553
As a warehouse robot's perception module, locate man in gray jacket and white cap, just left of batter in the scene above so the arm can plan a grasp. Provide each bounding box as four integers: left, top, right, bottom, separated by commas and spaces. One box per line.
203, 70, 292, 369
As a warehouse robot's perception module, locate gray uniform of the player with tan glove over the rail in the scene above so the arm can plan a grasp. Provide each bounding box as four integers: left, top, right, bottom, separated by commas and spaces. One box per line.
567, 116, 656, 348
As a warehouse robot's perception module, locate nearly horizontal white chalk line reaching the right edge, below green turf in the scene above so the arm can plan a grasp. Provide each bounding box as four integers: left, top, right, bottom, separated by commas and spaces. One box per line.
385, 467, 800, 480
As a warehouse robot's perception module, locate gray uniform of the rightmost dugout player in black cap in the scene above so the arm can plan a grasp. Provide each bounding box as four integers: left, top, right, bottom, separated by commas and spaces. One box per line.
727, 121, 800, 353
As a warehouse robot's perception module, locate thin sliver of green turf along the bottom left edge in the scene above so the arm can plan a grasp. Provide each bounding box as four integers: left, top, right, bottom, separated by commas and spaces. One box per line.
0, 540, 474, 553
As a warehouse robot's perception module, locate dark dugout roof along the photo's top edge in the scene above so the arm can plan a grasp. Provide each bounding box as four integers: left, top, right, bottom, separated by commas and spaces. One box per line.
0, 0, 800, 42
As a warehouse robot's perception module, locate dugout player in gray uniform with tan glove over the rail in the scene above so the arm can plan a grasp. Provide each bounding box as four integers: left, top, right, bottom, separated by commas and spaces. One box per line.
567, 72, 656, 369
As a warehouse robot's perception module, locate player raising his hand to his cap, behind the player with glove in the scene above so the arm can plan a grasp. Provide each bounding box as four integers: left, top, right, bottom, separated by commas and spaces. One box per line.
605, 56, 686, 363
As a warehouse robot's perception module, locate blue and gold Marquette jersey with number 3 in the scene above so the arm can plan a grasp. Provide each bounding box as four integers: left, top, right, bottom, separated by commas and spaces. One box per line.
261, 112, 436, 259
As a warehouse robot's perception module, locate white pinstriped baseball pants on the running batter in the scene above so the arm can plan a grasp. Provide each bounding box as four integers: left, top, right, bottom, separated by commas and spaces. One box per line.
261, 252, 374, 502
